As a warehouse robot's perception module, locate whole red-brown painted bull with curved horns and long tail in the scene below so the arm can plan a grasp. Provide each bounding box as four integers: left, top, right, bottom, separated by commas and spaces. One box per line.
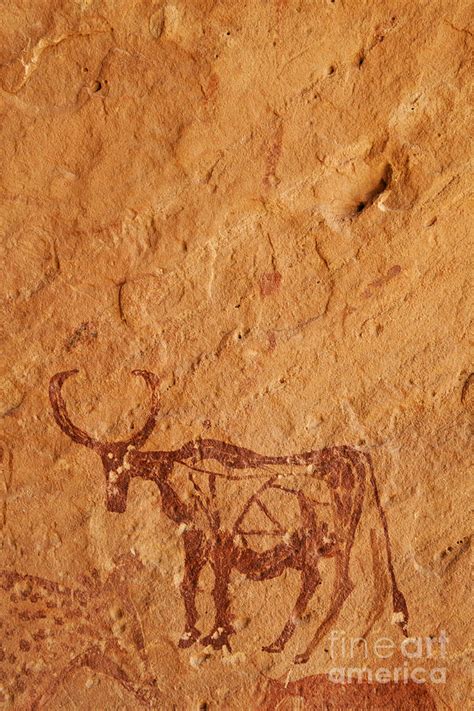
49, 370, 408, 662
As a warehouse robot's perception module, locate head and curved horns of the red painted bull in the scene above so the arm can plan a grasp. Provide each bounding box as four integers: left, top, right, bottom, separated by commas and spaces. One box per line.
49, 370, 159, 513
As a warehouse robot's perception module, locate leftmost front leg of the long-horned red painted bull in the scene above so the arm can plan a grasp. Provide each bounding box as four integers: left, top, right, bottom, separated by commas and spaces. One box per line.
178, 528, 208, 648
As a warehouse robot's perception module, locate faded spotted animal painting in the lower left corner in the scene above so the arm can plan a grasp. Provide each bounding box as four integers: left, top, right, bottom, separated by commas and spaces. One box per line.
0, 559, 161, 711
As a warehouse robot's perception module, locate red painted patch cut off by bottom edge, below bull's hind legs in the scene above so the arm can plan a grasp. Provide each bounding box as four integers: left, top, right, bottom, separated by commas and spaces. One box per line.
256, 674, 436, 711
